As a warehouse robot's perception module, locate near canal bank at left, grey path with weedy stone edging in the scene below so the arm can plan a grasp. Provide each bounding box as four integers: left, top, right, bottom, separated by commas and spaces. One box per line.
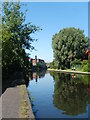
0, 74, 35, 119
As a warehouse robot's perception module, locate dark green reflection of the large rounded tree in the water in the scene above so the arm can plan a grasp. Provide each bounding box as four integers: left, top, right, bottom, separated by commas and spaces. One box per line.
50, 72, 88, 116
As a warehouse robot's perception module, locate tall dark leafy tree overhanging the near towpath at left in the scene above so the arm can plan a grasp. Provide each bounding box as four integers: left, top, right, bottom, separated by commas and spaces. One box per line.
2, 2, 40, 77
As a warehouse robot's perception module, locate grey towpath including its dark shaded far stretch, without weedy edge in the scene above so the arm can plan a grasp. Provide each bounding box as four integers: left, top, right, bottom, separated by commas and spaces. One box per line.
2, 72, 22, 118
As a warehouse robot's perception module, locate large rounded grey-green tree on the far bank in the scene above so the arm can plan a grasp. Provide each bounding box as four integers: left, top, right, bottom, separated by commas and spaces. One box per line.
52, 28, 87, 68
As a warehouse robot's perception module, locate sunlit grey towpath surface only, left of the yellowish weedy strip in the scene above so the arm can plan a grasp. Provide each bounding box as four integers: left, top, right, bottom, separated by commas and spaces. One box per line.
2, 86, 21, 118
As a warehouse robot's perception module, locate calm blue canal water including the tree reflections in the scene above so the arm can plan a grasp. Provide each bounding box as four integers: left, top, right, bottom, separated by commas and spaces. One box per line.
27, 71, 90, 118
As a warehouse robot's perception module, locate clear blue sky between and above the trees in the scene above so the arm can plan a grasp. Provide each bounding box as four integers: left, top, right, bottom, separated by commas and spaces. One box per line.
22, 2, 88, 62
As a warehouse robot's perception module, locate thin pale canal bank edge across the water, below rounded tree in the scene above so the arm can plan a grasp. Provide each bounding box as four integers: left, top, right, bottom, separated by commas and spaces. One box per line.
47, 69, 90, 75
